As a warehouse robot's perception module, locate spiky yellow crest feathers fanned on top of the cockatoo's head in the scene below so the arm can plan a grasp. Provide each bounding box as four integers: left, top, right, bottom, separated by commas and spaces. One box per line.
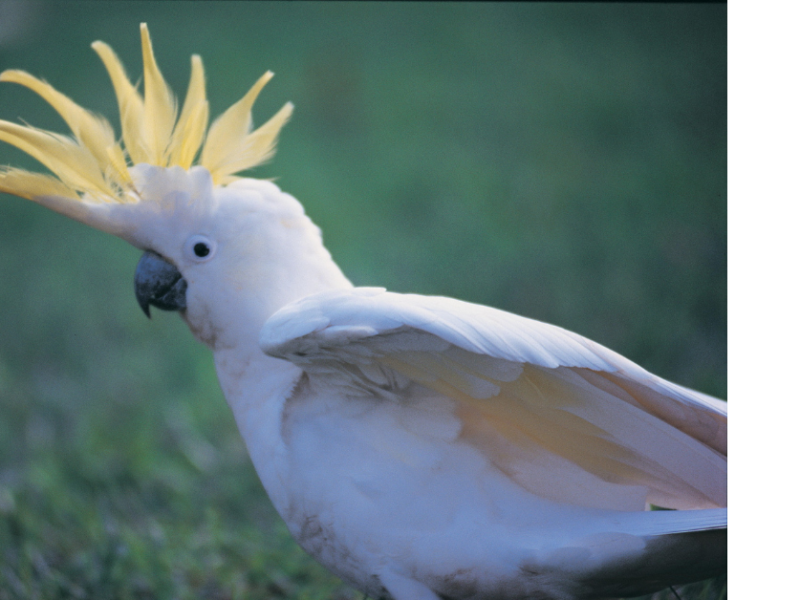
0, 23, 293, 202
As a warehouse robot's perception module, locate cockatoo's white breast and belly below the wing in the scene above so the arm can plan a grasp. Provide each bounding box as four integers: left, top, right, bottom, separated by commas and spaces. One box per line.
219, 328, 727, 600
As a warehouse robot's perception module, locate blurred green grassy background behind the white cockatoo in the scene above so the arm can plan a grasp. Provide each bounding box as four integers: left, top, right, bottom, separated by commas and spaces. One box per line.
0, 0, 728, 600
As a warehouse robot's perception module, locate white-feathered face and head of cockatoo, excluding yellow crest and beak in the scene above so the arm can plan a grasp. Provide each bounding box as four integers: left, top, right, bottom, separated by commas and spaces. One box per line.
113, 165, 351, 349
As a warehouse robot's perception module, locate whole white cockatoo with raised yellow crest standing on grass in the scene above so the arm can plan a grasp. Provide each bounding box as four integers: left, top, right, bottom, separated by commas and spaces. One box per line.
0, 25, 728, 600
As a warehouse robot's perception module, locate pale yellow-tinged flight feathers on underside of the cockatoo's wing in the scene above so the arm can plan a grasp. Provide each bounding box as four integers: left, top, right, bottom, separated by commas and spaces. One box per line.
378, 352, 727, 508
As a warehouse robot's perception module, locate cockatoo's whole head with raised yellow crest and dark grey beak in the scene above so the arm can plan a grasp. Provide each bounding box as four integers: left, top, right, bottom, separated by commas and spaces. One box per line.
0, 24, 349, 348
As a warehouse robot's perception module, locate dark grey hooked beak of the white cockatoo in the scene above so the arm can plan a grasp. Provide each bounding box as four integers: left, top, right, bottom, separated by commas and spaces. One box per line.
133, 250, 186, 317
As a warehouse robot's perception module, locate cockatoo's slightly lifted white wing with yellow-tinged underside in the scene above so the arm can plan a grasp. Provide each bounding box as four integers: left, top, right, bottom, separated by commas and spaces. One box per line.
260, 288, 728, 510
